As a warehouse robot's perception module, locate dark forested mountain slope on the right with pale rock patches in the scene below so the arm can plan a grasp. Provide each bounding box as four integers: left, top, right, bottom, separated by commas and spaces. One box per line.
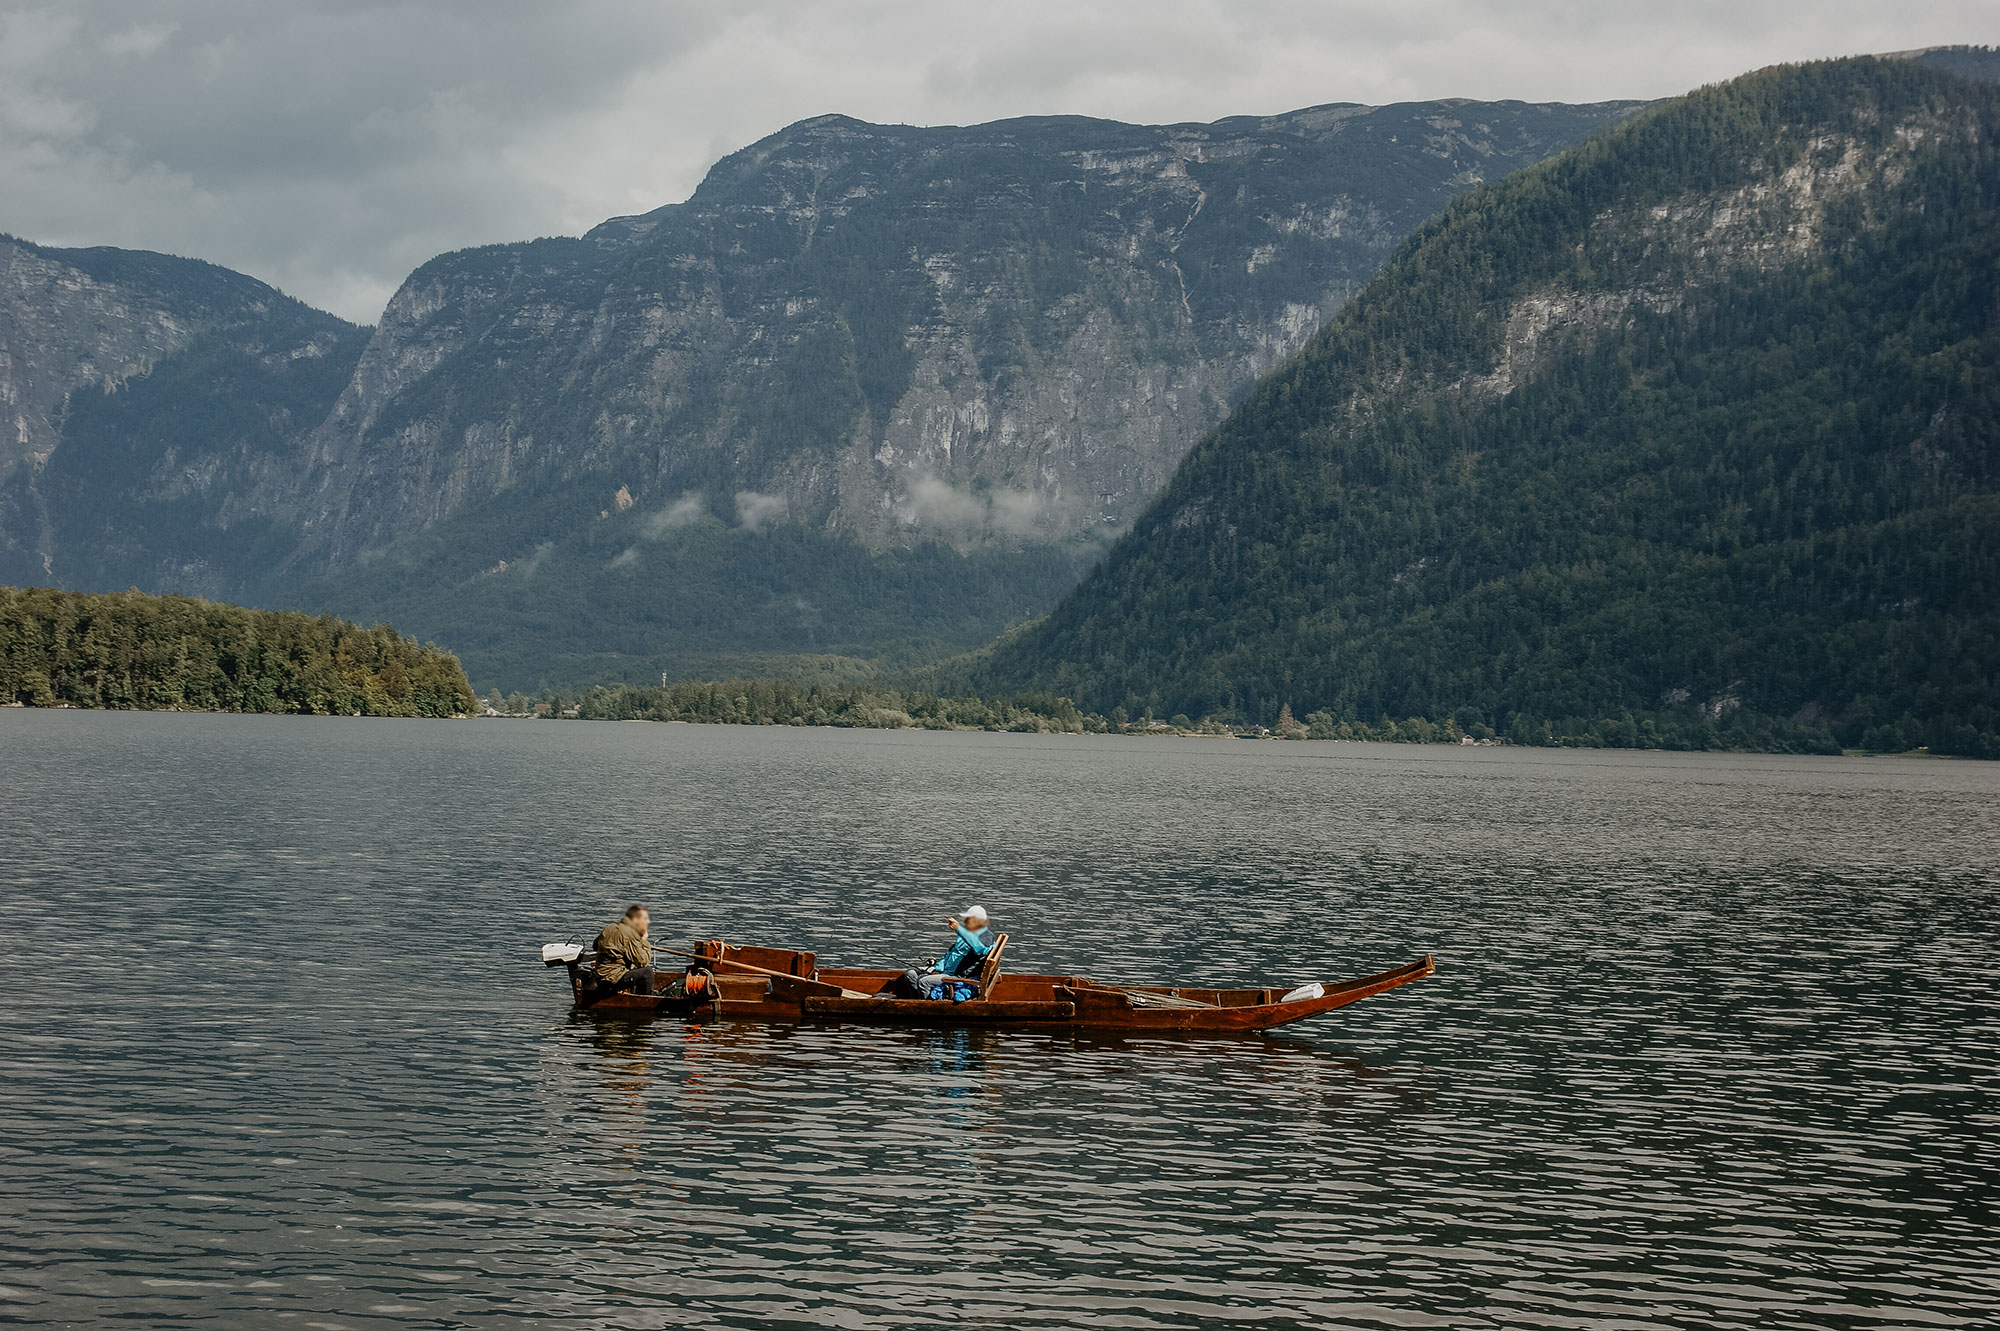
972, 58, 2000, 755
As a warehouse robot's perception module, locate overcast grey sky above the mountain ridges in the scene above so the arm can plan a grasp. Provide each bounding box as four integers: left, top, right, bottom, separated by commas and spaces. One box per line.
0, 0, 2000, 322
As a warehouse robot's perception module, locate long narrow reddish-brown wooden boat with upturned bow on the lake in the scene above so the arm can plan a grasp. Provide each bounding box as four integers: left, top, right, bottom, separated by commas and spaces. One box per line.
542, 933, 1436, 1031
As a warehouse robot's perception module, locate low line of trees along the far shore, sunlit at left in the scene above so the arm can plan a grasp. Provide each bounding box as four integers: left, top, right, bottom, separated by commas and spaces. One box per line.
0, 588, 1968, 757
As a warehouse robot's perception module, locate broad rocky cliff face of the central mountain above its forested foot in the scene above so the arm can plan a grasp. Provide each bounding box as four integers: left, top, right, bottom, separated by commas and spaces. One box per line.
296, 102, 1628, 566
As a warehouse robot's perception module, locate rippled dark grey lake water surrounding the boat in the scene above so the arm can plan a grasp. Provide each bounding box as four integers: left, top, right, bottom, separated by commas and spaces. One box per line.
0, 711, 2000, 1327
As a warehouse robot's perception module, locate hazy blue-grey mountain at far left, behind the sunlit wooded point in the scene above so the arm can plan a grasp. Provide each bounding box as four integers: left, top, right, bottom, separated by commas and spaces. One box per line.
0, 236, 368, 598
